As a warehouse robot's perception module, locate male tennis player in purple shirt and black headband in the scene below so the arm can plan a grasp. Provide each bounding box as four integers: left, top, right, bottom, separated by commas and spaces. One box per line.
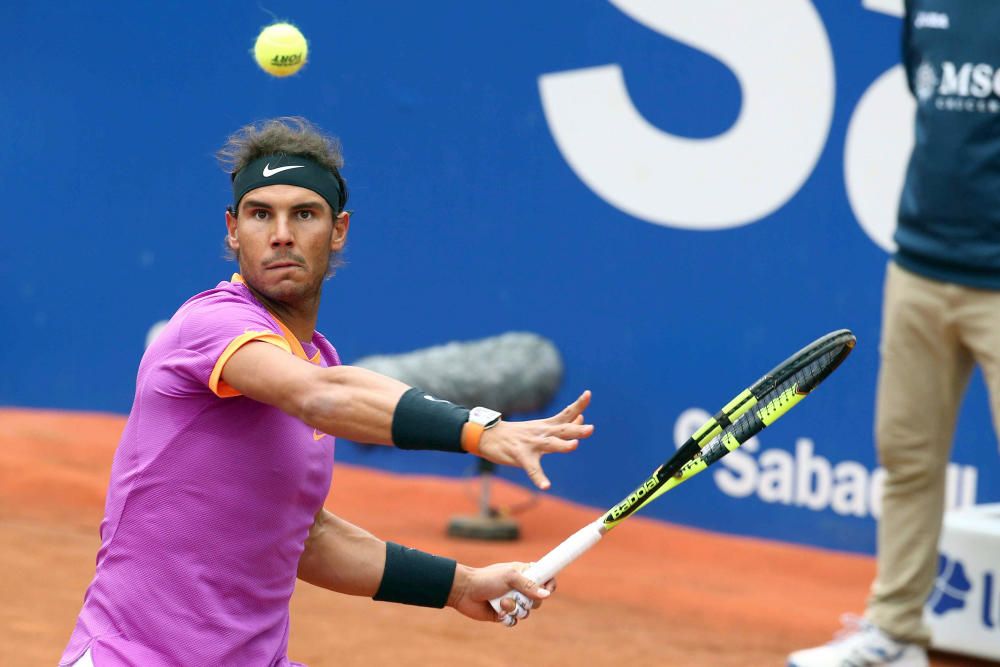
61, 119, 593, 667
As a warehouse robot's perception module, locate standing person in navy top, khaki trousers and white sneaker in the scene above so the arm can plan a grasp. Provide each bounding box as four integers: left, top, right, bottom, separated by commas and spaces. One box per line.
788, 0, 1000, 667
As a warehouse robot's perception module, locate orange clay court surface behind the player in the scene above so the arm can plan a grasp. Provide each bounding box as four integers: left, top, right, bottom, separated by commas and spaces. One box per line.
0, 409, 988, 667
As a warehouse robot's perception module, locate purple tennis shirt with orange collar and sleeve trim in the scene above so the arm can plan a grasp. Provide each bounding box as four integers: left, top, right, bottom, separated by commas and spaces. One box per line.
62, 275, 340, 667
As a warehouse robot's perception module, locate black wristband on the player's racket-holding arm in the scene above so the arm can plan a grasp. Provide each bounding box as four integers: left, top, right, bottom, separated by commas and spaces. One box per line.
372, 542, 457, 609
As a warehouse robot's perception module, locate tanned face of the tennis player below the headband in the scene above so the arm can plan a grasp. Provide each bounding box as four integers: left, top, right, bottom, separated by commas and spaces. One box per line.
226, 185, 349, 303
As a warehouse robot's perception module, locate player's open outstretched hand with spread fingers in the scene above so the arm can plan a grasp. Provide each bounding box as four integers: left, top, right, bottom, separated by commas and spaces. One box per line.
479, 391, 594, 490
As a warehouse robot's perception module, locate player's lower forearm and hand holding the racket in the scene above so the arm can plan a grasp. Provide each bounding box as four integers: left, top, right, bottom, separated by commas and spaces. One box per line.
298, 509, 555, 621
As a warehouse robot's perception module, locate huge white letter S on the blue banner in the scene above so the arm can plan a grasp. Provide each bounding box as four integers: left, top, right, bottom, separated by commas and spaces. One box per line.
539, 0, 834, 230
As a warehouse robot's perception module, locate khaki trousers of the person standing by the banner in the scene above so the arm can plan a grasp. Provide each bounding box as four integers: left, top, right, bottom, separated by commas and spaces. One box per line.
865, 262, 1000, 645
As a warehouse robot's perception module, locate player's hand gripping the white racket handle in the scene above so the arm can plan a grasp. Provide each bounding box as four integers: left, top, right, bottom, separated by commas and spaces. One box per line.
448, 563, 556, 625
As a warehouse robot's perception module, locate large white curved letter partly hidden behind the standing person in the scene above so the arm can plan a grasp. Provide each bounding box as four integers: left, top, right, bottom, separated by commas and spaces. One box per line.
844, 65, 916, 252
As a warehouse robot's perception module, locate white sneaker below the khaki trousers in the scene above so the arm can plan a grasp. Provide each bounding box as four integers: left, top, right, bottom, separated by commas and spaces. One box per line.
788, 614, 929, 667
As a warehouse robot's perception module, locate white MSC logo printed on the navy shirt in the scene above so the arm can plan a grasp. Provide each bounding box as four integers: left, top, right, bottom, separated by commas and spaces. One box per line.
913, 60, 1000, 113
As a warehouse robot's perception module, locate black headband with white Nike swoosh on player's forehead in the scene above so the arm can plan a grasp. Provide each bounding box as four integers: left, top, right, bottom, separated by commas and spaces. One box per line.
232, 153, 347, 215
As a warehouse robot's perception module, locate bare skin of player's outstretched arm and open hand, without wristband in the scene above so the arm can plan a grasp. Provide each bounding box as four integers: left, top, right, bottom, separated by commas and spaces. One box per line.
222, 341, 593, 489
